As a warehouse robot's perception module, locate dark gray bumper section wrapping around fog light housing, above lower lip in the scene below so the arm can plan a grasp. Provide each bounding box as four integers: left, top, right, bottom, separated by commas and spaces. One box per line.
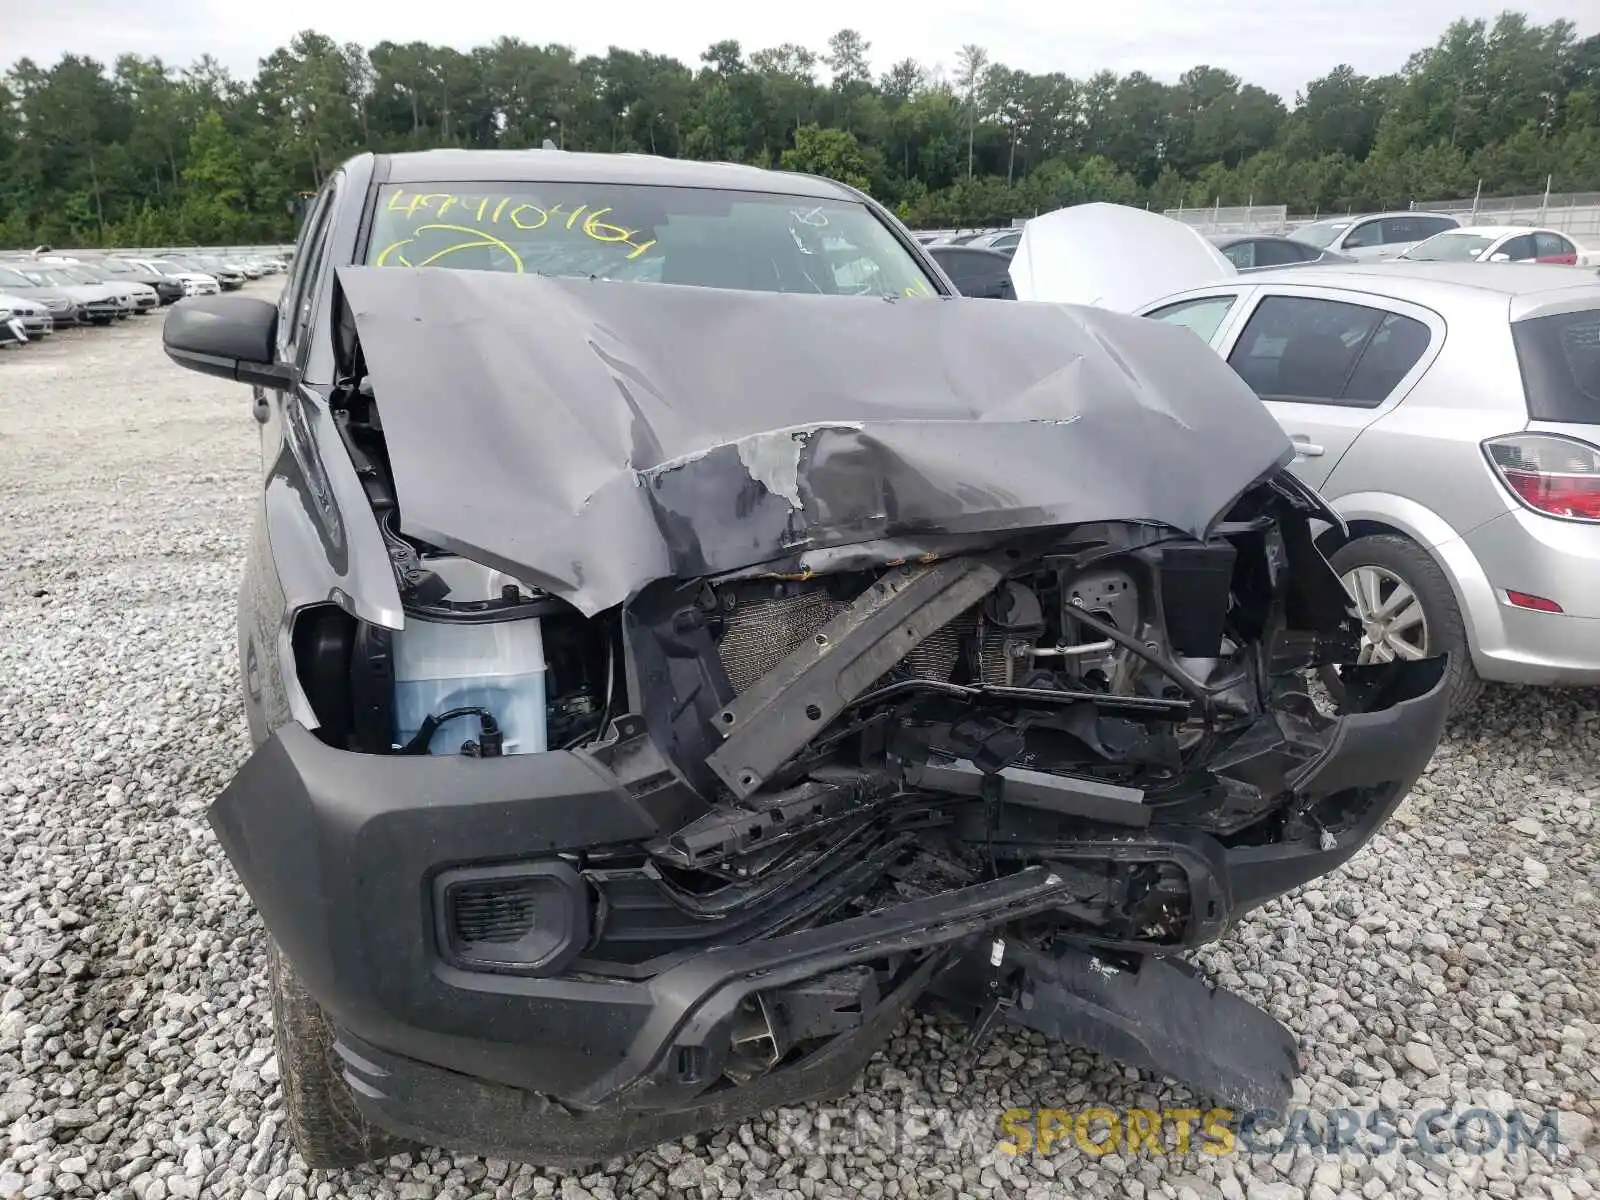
211, 726, 1061, 1107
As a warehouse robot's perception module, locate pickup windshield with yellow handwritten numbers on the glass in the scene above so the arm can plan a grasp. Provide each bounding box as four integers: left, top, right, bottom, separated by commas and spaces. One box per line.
366, 182, 934, 296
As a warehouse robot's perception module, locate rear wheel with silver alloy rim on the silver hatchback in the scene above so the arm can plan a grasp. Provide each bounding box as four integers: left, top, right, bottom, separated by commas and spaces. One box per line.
1322, 533, 1483, 717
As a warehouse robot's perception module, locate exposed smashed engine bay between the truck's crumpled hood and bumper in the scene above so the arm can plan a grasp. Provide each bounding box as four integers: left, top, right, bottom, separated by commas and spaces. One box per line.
296, 376, 1355, 971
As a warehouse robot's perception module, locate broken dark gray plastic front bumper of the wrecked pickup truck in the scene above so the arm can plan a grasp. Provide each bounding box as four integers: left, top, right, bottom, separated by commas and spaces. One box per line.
211, 659, 1445, 1162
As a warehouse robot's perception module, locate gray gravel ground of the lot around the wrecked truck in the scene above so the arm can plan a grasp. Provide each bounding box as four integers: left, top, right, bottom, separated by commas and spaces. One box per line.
0, 291, 1600, 1200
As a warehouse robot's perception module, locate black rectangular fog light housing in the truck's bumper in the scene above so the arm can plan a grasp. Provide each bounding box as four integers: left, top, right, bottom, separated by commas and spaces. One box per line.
434, 859, 589, 974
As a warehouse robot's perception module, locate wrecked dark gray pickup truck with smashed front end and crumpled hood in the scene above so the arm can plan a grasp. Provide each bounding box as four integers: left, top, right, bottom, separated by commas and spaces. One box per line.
165, 150, 1445, 1166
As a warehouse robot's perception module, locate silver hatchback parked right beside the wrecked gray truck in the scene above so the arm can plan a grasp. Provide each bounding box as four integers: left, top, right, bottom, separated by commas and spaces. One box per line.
1141, 262, 1600, 710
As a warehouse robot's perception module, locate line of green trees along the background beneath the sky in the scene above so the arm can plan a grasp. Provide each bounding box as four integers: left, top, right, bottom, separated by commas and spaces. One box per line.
0, 11, 1600, 246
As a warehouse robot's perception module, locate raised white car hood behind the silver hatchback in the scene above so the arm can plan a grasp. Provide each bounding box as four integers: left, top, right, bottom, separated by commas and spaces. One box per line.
1011, 203, 1238, 312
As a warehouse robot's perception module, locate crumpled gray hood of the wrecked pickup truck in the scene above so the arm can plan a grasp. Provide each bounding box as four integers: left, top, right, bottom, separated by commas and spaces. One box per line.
339, 267, 1293, 614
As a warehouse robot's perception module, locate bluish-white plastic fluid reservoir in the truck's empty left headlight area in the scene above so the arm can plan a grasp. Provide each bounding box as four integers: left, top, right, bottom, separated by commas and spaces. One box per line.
394, 557, 547, 754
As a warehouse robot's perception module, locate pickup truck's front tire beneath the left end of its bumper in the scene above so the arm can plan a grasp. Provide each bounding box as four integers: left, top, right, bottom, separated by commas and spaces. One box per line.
267, 936, 416, 1168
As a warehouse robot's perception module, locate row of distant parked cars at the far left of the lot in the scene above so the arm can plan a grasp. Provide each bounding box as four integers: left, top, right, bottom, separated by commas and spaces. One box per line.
0, 248, 285, 346
